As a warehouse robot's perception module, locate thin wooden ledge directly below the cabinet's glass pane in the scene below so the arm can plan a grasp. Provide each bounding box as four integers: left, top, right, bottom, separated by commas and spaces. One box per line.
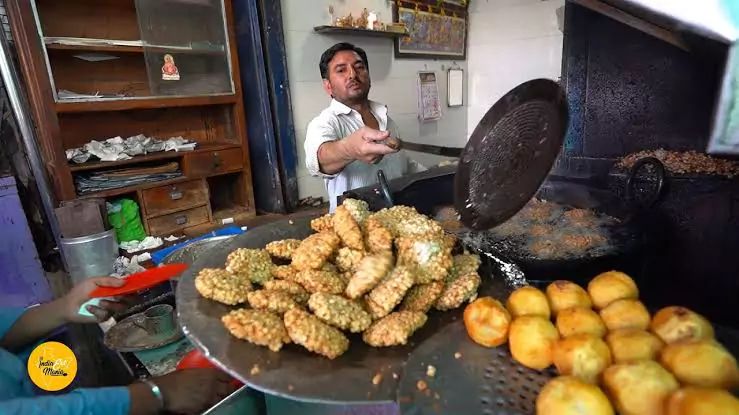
56, 94, 237, 113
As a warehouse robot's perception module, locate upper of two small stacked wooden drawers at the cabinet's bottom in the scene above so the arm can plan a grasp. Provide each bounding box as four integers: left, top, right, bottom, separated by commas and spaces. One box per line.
142, 180, 208, 218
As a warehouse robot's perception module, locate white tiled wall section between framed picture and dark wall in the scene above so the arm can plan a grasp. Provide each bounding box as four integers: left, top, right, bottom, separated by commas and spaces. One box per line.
467, 0, 564, 133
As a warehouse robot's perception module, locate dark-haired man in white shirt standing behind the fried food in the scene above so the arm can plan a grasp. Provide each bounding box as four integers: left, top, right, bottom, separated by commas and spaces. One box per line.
305, 43, 424, 212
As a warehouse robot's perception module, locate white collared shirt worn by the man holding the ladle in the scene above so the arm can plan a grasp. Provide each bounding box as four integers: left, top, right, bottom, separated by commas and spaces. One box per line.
305, 100, 425, 212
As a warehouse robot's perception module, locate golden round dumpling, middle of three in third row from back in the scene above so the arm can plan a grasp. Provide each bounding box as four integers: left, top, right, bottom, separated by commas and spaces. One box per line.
606, 329, 665, 363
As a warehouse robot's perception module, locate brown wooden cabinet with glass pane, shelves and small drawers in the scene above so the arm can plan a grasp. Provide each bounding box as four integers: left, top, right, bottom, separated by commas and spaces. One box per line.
5, 0, 256, 235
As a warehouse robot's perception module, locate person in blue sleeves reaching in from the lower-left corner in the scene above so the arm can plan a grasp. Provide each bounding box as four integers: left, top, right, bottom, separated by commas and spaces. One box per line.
0, 277, 234, 415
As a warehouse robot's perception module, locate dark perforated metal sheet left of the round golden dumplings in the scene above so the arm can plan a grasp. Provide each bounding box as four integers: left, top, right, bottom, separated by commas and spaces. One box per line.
398, 321, 555, 415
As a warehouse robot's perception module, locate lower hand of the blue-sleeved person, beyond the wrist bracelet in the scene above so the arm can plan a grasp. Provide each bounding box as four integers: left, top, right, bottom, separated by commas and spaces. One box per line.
154, 368, 238, 414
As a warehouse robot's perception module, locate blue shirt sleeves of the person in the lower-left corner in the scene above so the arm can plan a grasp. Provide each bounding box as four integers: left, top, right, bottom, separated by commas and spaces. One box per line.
0, 308, 131, 415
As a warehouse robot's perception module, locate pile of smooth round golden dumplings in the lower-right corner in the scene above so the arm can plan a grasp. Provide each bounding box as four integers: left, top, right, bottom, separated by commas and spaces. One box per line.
464, 271, 739, 415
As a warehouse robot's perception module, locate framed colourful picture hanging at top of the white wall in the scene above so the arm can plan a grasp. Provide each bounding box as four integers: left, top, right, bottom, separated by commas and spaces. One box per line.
393, 0, 468, 60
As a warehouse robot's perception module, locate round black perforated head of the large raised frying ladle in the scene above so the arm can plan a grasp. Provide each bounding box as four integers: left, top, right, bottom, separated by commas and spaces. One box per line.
454, 79, 568, 230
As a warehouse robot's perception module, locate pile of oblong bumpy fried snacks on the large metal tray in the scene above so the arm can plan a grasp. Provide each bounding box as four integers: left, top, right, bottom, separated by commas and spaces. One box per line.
195, 199, 480, 359
